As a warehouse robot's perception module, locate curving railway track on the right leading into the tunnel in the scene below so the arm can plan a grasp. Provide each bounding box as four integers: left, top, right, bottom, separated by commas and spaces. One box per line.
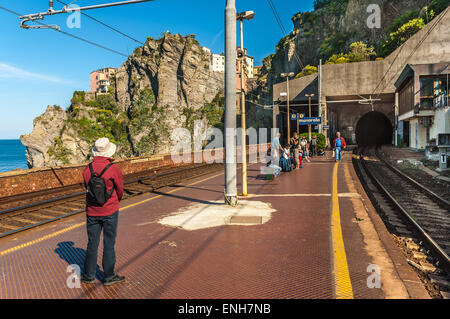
354, 148, 450, 298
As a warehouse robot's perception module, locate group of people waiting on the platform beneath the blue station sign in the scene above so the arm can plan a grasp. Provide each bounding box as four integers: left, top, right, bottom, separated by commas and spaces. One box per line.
270, 132, 317, 172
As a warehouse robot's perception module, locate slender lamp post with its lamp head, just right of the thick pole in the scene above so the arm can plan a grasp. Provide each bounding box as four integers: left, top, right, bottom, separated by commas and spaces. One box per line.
236, 11, 255, 196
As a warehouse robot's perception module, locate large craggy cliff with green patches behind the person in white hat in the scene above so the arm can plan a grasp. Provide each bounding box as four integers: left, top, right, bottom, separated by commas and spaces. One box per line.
21, 33, 224, 167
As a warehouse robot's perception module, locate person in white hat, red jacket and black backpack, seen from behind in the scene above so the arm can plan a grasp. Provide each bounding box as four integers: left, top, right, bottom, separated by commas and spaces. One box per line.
81, 137, 125, 286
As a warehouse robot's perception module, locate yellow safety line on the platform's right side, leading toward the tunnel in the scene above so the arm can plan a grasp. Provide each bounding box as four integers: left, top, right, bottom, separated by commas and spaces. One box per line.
331, 163, 353, 299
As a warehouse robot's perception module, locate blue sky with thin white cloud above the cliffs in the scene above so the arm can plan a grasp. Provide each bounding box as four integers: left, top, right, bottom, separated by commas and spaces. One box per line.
0, 0, 314, 139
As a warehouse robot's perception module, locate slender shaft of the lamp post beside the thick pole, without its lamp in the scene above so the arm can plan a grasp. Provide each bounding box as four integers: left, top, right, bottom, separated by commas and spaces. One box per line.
240, 19, 247, 196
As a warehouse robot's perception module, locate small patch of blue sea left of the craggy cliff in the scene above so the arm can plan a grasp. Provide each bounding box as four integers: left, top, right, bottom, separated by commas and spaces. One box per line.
0, 140, 28, 172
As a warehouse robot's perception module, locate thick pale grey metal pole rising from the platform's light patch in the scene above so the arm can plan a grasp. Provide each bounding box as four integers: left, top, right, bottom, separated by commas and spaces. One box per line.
225, 0, 237, 206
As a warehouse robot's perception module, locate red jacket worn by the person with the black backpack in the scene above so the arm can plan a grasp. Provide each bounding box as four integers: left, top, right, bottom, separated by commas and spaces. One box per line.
83, 156, 123, 216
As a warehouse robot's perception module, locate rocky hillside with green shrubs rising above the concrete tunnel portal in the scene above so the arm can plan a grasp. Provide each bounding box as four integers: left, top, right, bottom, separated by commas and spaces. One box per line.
252, 0, 431, 103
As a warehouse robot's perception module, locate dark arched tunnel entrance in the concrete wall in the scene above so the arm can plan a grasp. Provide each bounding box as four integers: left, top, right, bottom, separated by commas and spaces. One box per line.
356, 111, 392, 146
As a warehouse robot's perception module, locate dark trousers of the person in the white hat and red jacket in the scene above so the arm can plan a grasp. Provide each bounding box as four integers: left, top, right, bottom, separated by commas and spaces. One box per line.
84, 211, 119, 281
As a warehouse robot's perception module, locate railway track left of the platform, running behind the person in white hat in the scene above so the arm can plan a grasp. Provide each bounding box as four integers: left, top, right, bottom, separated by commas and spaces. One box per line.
0, 163, 223, 238
